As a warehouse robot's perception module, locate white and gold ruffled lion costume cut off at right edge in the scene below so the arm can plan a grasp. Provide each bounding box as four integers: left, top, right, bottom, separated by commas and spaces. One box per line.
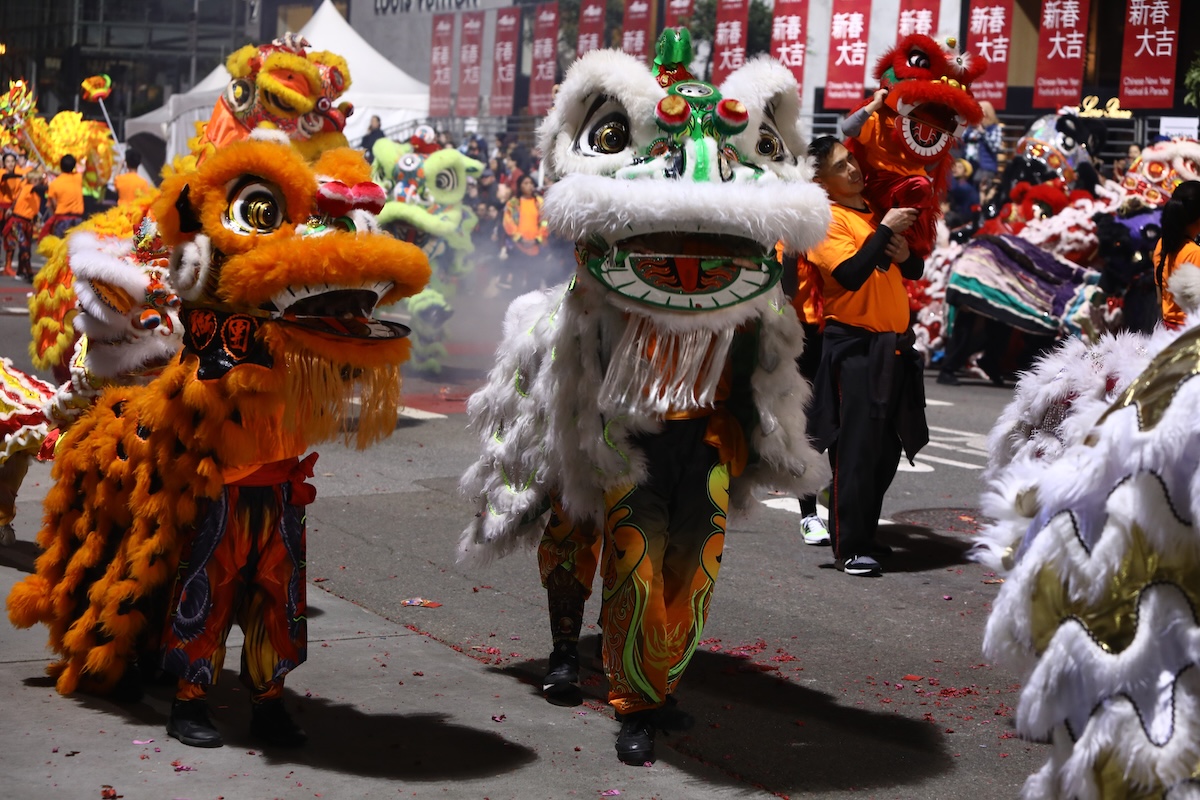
979, 265, 1200, 800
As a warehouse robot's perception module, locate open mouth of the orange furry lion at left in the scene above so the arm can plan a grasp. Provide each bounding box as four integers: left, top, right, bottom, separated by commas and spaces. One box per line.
262, 281, 409, 339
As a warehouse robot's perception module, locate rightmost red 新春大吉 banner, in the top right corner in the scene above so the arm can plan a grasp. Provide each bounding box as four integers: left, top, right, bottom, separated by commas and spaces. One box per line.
1120, 0, 1180, 108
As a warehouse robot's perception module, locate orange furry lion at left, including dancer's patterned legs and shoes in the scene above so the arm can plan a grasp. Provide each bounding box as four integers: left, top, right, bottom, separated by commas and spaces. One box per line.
8, 133, 430, 746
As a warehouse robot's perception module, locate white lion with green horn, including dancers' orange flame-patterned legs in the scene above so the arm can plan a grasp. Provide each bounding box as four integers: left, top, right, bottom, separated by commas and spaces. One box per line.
461, 31, 829, 764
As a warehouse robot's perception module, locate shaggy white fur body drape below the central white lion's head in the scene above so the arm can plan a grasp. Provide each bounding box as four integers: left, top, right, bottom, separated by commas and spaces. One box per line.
458, 273, 829, 564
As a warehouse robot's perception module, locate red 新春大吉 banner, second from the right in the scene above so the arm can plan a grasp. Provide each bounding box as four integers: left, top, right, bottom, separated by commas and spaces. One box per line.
1033, 0, 1090, 108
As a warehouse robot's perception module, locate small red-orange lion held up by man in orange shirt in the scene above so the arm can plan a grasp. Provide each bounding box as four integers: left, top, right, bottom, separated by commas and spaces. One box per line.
841, 34, 989, 258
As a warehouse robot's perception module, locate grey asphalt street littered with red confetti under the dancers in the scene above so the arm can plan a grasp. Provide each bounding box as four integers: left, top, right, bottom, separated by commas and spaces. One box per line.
0, 271, 1049, 800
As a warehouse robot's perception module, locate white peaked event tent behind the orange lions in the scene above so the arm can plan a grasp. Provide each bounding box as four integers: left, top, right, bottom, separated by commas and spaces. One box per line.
125, 0, 430, 172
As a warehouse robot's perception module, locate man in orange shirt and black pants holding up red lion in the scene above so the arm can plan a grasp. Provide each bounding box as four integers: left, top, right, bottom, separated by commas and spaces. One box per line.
808, 137, 929, 576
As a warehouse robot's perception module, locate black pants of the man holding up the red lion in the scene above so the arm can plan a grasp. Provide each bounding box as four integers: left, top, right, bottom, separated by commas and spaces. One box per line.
829, 351, 904, 559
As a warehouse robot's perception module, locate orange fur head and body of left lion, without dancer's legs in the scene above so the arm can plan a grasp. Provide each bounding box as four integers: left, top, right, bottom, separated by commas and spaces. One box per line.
8, 140, 430, 693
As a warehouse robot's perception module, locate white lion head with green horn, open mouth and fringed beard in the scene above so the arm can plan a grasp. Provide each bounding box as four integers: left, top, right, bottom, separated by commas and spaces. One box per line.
539, 30, 829, 410
